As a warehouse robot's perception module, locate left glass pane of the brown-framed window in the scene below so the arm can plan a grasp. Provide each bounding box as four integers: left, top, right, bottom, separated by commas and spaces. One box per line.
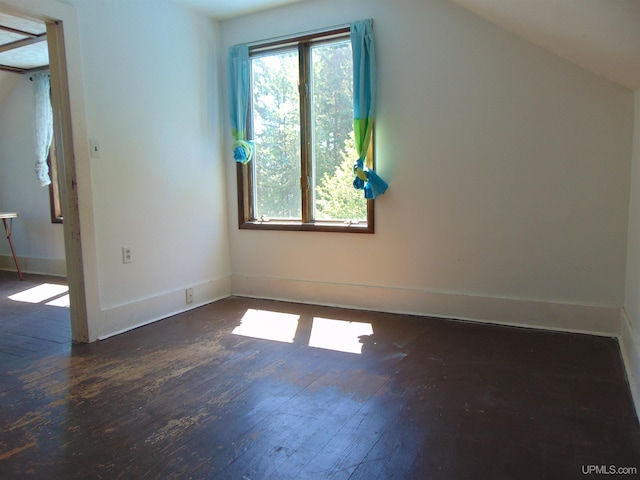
251, 50, 302, 220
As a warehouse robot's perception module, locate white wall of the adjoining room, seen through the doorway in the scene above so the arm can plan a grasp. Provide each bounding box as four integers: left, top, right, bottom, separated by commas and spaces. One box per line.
0, 74, 66, 275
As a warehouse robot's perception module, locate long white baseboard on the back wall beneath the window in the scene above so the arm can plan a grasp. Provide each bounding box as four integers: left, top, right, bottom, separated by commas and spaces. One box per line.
231, 275, 620, 337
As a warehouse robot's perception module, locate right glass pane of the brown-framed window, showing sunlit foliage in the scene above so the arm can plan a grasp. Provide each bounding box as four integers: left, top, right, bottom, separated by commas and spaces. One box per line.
311, 40, 367, 220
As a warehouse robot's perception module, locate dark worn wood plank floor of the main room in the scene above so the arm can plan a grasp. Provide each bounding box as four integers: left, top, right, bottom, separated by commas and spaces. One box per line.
0, 297, 640, 480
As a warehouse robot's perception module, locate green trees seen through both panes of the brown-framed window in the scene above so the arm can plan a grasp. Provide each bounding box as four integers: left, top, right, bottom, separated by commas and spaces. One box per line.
252, 41, 366, 220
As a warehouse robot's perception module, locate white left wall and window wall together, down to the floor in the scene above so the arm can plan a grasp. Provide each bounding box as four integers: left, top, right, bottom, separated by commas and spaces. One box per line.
0, 0, 637, 340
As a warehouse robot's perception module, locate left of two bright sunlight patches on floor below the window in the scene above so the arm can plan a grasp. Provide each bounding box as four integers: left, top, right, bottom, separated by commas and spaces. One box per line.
233, 309, 300, 343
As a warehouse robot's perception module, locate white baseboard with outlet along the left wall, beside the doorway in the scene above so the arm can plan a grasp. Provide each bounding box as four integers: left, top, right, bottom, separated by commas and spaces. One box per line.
95, 277, 231, 342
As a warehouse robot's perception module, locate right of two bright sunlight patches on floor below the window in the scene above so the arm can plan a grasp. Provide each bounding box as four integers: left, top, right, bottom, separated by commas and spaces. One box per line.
309, 317, 373, 353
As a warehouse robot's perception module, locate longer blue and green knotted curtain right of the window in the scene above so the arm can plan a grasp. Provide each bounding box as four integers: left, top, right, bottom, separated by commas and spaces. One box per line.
350, 20, 389, 199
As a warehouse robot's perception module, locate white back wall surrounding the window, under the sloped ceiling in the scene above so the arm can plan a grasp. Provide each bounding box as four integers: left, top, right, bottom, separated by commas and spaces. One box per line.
222, 0, 633, 334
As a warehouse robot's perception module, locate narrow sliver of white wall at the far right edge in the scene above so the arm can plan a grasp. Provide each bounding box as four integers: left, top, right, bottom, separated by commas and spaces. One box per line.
621, 90, 640, 412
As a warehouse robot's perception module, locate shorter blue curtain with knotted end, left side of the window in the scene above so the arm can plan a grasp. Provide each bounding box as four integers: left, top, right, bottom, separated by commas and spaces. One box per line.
229, 45, 253, 163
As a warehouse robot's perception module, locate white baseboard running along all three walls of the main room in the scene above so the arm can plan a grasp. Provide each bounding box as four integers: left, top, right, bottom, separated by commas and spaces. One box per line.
84, 275, 640, 420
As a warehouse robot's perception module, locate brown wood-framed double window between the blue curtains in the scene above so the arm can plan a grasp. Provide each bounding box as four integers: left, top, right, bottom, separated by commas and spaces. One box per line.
237, 28, 373, 233
